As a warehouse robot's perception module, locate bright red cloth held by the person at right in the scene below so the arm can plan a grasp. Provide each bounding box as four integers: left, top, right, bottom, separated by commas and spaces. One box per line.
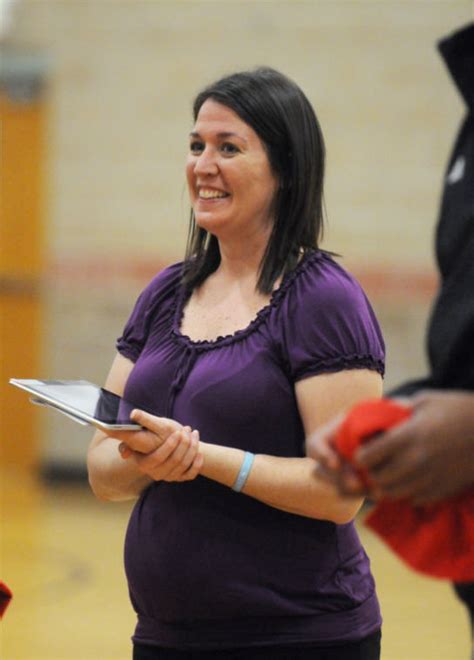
336, 399, 474, 582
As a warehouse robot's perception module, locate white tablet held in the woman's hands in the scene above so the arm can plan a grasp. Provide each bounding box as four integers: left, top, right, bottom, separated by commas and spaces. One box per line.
10, 378, 141, 431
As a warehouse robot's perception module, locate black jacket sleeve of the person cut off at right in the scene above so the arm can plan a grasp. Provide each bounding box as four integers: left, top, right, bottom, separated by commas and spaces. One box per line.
392, 23, 474, 395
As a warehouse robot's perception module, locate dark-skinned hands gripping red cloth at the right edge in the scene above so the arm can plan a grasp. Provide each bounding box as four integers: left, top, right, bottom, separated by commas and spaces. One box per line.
307, 391, 474, 505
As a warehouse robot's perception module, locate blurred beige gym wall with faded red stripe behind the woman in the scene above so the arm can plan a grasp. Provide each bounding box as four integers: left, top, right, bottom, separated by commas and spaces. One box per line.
2, 0, 474, 470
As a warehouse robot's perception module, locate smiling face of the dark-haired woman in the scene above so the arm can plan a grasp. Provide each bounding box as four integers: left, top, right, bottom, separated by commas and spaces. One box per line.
186, 99, 278, 239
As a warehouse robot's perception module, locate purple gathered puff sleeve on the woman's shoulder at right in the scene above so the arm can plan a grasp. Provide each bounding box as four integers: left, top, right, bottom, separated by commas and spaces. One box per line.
281, 253, 385, 381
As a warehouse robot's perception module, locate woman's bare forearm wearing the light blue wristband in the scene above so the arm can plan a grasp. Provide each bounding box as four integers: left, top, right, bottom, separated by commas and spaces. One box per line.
200, 442, 363, 524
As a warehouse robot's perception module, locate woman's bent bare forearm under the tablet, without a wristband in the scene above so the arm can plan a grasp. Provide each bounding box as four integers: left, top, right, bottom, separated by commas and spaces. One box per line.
87, 438, 152, 502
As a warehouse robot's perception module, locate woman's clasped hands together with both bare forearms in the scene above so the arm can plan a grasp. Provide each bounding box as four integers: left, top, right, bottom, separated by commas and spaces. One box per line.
89, 411, 362, 524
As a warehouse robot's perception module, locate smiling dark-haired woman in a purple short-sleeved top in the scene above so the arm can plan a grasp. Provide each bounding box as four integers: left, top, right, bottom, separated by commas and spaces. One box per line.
88, 68, 384, 660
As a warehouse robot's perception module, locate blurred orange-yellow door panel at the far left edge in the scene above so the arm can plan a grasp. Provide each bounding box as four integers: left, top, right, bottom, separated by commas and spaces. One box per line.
0, 84, 45, 470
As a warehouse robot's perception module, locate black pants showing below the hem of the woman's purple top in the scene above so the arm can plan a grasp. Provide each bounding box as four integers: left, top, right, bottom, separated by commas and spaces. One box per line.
133, 631, 380, 660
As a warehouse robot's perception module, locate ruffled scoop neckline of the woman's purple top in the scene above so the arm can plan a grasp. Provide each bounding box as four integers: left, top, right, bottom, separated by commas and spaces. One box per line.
172, 250, 323, 351
